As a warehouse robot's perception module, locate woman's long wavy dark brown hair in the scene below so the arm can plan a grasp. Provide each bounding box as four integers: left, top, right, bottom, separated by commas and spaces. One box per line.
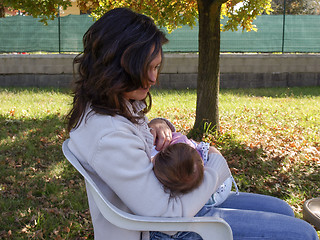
67, 8, 168, 131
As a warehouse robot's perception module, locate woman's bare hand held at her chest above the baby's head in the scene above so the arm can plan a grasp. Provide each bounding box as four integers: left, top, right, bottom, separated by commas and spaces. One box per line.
148, 119, 172, 151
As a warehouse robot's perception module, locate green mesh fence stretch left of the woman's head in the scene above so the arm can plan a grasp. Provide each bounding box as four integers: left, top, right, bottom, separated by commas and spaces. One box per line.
0, 15, 93, 52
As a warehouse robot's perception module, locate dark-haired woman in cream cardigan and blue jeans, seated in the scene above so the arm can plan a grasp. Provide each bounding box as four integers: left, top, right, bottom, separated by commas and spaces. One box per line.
68, 8, 315, 240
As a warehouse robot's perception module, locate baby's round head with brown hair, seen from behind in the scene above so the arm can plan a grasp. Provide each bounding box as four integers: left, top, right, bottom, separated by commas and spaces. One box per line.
153, 143, 204, 197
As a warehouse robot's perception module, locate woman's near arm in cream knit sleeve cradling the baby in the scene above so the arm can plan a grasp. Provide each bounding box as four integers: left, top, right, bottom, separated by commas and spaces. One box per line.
90, 128, 223, 217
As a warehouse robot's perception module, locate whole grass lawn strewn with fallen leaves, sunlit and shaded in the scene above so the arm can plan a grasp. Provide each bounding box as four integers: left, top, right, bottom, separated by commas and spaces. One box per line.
0, 87, 320, 239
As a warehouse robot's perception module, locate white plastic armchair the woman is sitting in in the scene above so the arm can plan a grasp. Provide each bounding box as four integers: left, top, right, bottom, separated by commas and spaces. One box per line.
62, 139, 233, 240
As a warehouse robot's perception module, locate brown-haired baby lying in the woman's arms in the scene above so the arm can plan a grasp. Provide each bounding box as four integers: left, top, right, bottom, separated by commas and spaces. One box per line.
151, 132, 238, 206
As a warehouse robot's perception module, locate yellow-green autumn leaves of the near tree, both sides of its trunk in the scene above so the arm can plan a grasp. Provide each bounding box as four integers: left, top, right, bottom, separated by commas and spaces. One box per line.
77, 0, 272, 32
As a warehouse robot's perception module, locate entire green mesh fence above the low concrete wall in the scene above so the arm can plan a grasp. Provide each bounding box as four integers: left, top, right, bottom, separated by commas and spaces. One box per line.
0, 15, 320, 53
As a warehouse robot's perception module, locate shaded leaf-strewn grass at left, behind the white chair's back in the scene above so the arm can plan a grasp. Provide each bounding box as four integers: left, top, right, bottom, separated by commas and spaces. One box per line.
0, 115, 93, 239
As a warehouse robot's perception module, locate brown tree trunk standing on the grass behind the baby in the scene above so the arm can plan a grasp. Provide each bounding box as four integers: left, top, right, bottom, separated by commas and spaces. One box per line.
191, 0, 226, 137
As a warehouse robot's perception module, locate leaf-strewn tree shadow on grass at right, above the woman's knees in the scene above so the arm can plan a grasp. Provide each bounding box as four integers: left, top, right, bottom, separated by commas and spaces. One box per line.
202, 131, 320, 204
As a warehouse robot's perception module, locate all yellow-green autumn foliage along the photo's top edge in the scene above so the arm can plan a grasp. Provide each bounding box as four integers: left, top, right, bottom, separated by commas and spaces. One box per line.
0, 0, 276, 32
